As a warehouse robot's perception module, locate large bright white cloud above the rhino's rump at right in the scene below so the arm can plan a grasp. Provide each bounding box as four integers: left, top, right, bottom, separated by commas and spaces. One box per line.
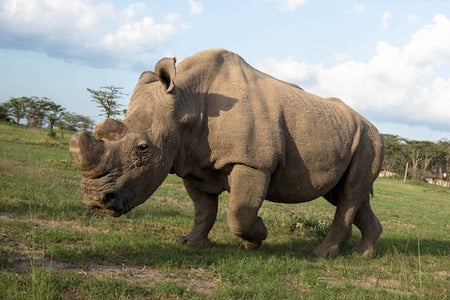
260, 15, 450, 132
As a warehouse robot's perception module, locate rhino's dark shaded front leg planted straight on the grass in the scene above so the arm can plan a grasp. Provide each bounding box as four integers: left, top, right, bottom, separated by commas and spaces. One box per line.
178, 180, 218, 245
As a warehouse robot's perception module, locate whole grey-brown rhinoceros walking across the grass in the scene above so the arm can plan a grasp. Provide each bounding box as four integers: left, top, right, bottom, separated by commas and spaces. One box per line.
69, 49, 383, 257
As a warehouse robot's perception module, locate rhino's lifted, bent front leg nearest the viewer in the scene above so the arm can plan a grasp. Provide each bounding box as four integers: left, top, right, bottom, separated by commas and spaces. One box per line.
227, 165, 270, 250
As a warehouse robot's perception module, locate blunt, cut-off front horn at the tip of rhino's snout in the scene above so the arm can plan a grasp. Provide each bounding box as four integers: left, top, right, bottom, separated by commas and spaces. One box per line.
69, 132, 105, 177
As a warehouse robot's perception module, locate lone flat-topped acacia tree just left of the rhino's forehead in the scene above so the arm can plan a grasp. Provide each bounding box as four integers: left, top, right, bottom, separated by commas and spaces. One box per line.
87, 85, 125, 118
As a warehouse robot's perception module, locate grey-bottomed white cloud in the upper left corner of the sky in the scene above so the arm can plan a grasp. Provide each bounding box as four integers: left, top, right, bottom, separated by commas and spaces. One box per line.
0, 0, 185, 67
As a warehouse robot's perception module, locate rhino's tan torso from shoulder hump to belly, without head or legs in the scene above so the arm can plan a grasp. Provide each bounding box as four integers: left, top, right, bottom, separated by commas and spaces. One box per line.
178, 50, 382, 202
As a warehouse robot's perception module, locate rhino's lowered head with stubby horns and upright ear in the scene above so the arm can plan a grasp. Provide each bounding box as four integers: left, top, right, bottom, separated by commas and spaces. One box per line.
69, 59, 177, 217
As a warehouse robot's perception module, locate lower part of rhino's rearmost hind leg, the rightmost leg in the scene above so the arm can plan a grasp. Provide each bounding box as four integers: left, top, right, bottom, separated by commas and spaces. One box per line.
353, 198, 383, 256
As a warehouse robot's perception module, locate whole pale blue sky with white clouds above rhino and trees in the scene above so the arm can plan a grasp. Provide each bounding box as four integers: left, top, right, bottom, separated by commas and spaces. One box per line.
0, 0, 450, 141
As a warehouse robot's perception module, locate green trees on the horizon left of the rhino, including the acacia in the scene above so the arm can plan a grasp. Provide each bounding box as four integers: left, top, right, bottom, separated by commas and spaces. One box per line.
0, 86, 126, 134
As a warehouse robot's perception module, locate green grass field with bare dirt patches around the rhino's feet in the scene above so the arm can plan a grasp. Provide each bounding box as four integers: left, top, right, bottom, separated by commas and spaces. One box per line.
0, 124, 450, 299
